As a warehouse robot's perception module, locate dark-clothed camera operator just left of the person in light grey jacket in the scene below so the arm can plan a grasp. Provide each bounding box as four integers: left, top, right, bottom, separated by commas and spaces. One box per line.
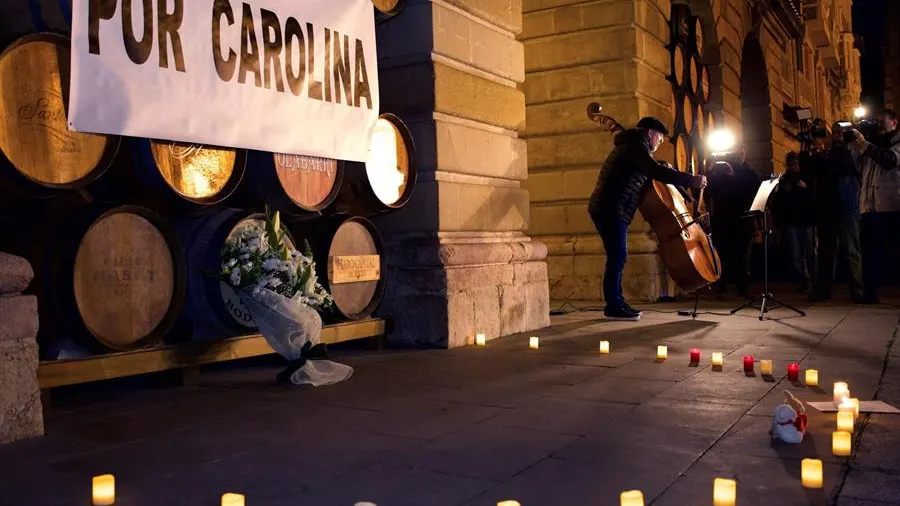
809, 122, 863, 302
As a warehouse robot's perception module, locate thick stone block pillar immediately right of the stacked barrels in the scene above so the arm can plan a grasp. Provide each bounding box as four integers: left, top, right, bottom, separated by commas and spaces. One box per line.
377, 0, 549, 347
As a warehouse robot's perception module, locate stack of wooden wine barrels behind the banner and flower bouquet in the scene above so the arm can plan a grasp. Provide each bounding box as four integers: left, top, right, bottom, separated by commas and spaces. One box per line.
0, 0, 416, 359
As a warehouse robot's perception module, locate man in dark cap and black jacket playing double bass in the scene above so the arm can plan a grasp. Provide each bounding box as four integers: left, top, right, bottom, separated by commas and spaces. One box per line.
588, 117, 706, 321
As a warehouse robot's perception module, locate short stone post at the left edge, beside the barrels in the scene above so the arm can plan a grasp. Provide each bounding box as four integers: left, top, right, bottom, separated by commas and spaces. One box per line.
0, 253, 44, 444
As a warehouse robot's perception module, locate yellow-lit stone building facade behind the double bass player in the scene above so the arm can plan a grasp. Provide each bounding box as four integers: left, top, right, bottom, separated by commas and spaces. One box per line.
519, 0, 861, 301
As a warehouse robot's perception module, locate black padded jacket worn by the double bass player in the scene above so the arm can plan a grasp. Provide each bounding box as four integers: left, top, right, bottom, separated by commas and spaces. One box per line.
588, 128, 700, 224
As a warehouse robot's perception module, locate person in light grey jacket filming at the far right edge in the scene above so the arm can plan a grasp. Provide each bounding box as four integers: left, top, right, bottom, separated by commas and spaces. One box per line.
852, 110, 900, 304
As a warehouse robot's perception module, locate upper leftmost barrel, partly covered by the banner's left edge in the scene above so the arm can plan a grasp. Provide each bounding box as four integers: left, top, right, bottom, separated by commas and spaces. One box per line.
0, 33, 120, 197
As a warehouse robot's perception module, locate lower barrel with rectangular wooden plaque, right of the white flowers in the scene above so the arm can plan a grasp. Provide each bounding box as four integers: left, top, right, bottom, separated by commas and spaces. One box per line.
292, 215, 385, 321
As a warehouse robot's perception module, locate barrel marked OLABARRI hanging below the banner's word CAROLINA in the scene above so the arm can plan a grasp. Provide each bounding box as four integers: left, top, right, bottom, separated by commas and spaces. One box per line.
244, 151, 346, 219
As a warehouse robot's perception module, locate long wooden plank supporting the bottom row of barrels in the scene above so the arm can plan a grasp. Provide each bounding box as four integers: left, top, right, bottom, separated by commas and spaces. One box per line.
38, 318, 386, 389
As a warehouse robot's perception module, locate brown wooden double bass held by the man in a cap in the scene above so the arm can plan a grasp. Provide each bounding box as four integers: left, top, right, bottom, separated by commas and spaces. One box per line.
587, 102, 722, 292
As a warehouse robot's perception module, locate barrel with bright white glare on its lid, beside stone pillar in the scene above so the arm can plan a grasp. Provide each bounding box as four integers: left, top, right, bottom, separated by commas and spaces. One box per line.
335, 114, 416, 216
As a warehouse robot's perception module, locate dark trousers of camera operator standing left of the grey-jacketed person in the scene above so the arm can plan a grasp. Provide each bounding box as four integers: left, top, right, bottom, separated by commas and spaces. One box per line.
814, 217, 863, 299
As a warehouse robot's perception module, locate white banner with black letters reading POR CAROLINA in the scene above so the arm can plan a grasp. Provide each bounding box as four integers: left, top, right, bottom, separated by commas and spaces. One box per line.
68, 0, 379, 161
